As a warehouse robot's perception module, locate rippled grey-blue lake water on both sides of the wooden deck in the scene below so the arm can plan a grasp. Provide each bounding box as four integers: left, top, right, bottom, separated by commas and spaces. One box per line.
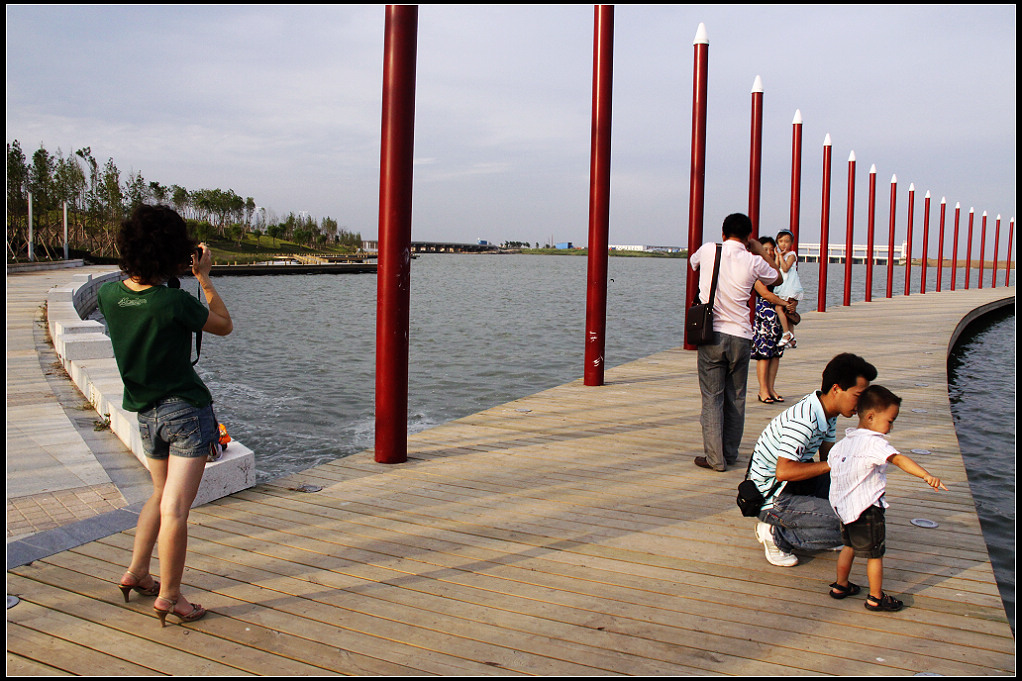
186, 255, 1015, 627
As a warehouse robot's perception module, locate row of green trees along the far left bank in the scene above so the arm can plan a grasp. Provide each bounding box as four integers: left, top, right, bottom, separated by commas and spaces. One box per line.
7, 140, 362, 260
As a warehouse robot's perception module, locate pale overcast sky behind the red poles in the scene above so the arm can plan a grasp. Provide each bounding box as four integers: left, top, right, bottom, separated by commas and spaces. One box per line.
6, 5, 1016, 248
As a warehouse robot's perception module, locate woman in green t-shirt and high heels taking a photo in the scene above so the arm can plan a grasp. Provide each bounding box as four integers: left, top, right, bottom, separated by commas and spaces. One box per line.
99, 206, 233, 626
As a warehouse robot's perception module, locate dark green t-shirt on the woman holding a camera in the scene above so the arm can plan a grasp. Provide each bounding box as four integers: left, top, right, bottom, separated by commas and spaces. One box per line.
98, 281, 213, 411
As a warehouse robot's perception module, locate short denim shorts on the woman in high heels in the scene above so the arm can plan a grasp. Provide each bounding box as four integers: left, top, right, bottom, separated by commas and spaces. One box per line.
138, 397, 219, 459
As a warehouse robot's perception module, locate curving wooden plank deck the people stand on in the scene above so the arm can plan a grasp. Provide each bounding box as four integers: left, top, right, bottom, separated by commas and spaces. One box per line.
7, 287, 1015, 676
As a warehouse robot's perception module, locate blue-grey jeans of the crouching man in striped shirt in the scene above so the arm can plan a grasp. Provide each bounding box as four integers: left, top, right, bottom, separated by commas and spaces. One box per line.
759, 473, 841, 553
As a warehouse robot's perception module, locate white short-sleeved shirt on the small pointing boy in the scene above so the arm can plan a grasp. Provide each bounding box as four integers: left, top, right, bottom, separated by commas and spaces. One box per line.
827, 428, 898, 525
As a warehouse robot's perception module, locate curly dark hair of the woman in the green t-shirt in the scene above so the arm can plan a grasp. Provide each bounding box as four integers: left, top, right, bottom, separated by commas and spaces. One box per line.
117, 206, 198, 284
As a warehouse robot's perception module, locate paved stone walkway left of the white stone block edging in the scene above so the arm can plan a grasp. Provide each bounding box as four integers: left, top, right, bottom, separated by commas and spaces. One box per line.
6, 266, 151, 563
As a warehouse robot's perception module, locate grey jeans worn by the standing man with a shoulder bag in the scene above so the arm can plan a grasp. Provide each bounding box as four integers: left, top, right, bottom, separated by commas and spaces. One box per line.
698, 333, 752, 470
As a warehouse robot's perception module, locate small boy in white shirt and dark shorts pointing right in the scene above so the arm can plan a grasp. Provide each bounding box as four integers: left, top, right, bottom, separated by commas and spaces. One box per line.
829, 385, 947, 612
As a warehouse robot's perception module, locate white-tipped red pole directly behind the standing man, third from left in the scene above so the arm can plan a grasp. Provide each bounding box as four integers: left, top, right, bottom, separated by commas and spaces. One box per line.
685, 24, 709, 350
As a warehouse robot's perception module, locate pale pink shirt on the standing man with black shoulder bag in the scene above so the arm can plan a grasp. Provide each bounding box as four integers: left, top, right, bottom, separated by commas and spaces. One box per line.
689, 239, 778, 341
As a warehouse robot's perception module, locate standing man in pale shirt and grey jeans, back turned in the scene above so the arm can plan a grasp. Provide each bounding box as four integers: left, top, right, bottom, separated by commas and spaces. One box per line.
689, 213, 781, 470
